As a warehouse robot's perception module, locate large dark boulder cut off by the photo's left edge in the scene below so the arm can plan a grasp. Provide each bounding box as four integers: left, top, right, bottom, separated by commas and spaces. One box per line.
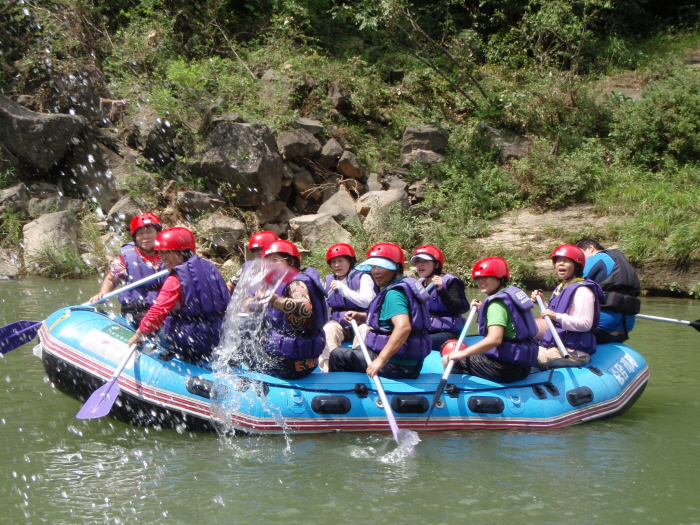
0, 95, 86, 171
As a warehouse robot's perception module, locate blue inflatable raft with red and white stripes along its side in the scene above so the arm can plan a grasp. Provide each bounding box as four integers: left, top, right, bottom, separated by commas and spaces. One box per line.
35, 307, 649, 434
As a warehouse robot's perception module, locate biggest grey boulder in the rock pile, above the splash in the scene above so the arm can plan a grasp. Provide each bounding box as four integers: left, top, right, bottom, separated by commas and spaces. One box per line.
188, 122, 284, 206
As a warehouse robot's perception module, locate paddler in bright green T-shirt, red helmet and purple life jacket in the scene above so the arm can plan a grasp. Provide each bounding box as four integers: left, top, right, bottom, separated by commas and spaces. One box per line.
442, 257, 537, 383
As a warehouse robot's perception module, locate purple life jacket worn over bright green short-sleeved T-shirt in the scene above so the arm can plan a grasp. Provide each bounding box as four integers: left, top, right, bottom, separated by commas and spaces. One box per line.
479, 286, 539, 370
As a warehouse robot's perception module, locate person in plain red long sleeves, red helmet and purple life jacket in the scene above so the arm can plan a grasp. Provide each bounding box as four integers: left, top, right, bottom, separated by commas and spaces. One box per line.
129, 227, 230, 363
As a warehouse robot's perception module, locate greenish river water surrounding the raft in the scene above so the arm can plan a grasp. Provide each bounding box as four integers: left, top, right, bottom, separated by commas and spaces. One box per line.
0, 279, 700, 525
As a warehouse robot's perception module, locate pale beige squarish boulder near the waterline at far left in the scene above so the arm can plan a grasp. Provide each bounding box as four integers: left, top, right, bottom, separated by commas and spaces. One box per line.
22, 211, 79, 264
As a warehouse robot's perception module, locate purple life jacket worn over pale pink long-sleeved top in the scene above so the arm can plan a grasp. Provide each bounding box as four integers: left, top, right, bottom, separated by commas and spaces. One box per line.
540, 279, 605, 355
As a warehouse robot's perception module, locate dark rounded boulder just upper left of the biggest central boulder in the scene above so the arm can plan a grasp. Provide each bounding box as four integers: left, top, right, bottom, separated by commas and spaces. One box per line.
123, 106, 177, 165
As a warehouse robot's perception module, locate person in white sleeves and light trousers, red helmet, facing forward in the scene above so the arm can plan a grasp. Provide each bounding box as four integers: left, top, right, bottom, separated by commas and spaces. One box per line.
319, 243, 379, 372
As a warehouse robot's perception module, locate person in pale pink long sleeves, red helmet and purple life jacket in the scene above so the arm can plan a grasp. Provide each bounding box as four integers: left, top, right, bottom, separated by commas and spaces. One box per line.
531, 244, 603, 370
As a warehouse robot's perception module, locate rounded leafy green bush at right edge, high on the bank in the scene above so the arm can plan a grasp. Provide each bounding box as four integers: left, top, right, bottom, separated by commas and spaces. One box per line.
610, 67, 700, 170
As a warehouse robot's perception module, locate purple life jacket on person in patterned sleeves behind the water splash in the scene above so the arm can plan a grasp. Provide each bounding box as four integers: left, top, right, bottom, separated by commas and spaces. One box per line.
263, 267, 328, 360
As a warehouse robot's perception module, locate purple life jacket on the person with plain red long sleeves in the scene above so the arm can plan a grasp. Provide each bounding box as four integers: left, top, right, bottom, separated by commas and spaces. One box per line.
162, 255, 231, 360
